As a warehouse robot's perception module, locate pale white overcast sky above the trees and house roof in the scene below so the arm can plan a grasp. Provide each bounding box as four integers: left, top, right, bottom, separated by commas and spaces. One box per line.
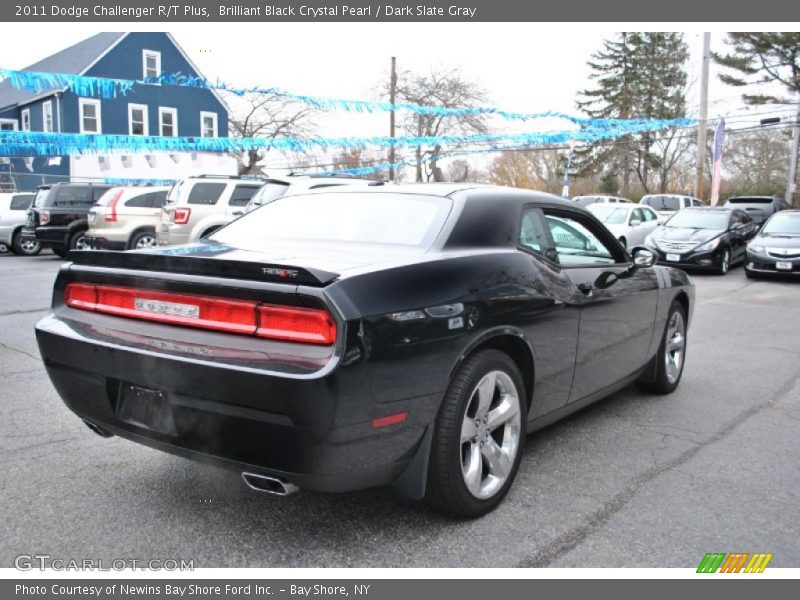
0, 23, 786, 171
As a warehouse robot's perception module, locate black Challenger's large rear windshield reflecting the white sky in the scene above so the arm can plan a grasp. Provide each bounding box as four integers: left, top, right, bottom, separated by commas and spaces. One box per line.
212, 193, 451, 250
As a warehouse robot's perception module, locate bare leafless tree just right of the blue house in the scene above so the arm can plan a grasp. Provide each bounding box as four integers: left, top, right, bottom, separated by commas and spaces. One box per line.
230, 94, 313, 175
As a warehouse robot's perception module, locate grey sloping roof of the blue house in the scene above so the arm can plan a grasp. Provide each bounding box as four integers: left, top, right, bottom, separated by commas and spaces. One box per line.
0, 32, 126, 108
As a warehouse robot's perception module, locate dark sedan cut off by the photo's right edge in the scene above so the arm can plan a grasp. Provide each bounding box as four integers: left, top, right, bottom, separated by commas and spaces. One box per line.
744, 210, 800, 277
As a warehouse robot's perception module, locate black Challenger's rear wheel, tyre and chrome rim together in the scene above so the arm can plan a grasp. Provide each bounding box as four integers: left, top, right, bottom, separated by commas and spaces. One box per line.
425, 350, 527, 517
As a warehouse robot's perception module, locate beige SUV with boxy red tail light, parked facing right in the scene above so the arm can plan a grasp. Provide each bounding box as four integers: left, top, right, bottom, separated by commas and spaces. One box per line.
156, 175, 264, 246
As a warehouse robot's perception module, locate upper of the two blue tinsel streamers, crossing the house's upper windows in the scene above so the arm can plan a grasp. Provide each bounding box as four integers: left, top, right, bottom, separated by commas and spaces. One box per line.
0, 69, 692, 127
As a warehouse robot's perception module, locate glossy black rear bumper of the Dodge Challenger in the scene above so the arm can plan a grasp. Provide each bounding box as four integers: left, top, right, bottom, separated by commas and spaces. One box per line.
36, 315, 438, 492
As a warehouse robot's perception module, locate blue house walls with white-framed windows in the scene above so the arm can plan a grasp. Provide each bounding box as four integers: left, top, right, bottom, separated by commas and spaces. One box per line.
0, 32, 228, 190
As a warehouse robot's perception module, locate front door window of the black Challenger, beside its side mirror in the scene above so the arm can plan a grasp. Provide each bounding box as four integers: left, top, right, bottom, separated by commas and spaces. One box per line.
545, 211, 622, 267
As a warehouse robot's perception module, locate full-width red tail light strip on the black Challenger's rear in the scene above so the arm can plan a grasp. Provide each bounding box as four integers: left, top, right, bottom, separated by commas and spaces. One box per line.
64, 283, 336, 345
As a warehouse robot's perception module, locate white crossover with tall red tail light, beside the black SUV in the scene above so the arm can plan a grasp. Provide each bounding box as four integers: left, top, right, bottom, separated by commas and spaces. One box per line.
85, 187, 169, 250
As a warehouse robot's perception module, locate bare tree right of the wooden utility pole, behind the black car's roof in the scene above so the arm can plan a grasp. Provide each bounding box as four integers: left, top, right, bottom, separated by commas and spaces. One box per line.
390, 69, 487, 181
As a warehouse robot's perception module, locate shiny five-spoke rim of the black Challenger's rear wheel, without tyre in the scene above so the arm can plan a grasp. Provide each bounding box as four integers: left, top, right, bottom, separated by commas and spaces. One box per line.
461, 371, 521, 499
